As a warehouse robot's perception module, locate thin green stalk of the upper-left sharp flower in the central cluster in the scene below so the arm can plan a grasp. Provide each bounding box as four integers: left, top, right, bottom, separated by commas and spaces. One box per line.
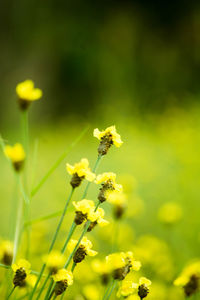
29, 188, 74, 300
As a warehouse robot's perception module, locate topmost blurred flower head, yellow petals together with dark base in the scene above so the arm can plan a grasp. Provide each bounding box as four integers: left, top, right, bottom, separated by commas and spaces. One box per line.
16, 80, 42, 110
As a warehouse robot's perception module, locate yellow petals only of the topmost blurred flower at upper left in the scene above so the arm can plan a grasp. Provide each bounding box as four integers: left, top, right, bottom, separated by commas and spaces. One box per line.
16, 80, 42, 101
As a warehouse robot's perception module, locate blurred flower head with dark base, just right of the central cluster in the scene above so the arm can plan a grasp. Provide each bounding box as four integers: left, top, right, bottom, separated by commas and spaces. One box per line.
107, 191, 127, 219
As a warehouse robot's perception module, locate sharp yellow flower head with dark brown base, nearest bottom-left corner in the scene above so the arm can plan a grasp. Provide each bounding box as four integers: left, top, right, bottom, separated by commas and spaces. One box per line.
12, 259, 31, 287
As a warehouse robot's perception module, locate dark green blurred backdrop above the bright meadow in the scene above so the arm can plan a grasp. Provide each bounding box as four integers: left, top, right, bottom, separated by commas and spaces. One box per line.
0, 0, 200, 122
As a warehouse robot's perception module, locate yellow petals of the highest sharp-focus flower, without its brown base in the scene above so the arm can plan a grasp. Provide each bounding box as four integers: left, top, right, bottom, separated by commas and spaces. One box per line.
94, 126, 123, 147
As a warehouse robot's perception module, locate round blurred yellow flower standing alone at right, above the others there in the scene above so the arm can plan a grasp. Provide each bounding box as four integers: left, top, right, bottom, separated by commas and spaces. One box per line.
158, 202, 183, 225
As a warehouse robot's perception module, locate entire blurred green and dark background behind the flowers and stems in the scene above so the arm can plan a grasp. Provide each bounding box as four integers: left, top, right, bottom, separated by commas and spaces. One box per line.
0, 0, 200, 300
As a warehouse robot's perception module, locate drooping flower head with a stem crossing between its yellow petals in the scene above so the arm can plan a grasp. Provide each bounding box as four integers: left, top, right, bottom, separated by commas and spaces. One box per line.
67, 236, 97, 264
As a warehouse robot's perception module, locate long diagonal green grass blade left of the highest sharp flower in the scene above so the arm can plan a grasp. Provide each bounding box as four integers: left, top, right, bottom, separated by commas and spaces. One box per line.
31, 126, 89, 197
